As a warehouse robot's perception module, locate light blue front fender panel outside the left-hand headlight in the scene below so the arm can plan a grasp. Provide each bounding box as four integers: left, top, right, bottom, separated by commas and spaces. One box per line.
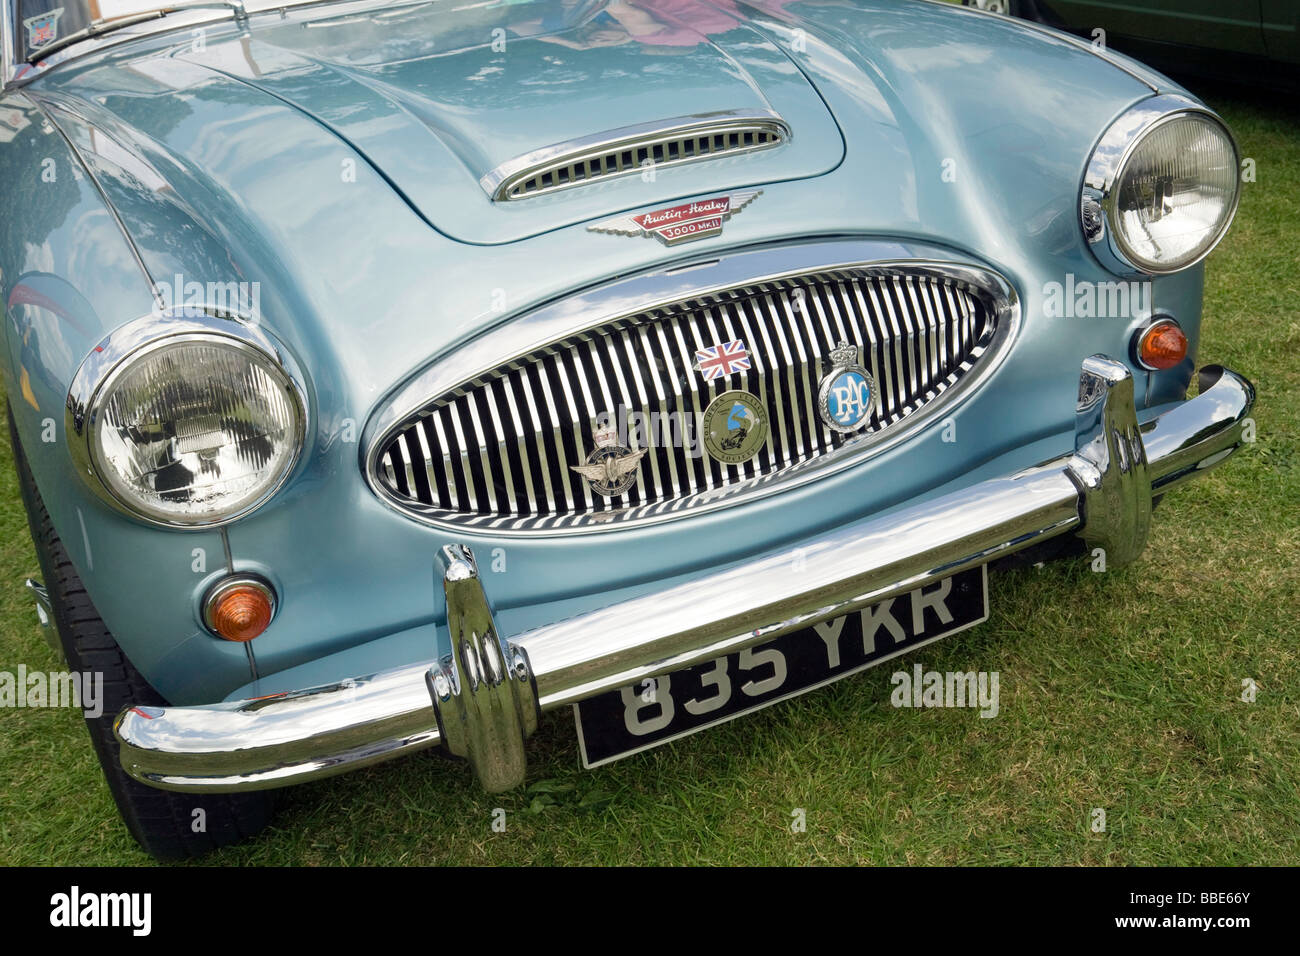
0, 92, 250, 701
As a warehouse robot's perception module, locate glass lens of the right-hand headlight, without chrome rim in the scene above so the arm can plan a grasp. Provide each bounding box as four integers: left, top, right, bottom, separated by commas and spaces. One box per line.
1110, 113, 1238, 272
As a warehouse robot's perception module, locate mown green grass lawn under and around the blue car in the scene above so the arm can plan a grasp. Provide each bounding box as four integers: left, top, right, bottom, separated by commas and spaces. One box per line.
0, 91, 1300, 865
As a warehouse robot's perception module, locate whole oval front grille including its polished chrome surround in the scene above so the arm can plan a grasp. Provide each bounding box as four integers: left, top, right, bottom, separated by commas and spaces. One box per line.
363, 241, 1021, 536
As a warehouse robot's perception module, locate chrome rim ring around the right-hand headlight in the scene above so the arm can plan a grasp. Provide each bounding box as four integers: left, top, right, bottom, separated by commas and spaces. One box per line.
1079, 94, 1242, 276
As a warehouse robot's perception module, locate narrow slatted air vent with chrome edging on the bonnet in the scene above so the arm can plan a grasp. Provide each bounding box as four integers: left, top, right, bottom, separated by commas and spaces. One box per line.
481, 111, 790, 202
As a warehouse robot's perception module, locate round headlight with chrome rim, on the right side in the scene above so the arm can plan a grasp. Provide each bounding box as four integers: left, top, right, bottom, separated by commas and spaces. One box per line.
1080, 95, 1240, 274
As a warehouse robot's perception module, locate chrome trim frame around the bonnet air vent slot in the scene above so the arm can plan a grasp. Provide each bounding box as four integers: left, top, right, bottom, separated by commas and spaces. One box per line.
478, 109, 790, 203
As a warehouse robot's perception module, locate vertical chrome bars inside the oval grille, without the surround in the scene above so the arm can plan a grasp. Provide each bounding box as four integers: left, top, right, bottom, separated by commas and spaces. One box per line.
373, 267, 998, 531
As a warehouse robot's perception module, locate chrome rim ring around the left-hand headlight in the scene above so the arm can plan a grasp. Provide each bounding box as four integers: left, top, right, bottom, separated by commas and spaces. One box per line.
64, 306, 311, 531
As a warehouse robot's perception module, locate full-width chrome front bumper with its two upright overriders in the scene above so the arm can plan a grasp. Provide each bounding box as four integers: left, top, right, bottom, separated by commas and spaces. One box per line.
116, 355, 1255, 792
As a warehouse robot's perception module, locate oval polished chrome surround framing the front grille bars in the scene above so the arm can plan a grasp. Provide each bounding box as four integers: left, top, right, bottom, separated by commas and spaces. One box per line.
360, 239, 1022, 537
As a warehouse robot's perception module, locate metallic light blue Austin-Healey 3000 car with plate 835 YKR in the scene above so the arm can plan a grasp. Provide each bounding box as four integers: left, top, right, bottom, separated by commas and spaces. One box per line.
0, 0, 1253, 856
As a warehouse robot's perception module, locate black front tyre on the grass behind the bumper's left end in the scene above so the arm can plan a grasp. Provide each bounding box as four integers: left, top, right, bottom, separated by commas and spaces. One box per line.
5, 403, 272, 860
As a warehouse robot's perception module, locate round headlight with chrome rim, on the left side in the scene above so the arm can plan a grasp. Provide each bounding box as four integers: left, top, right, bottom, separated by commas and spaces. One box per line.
69, 310, 306, 527
